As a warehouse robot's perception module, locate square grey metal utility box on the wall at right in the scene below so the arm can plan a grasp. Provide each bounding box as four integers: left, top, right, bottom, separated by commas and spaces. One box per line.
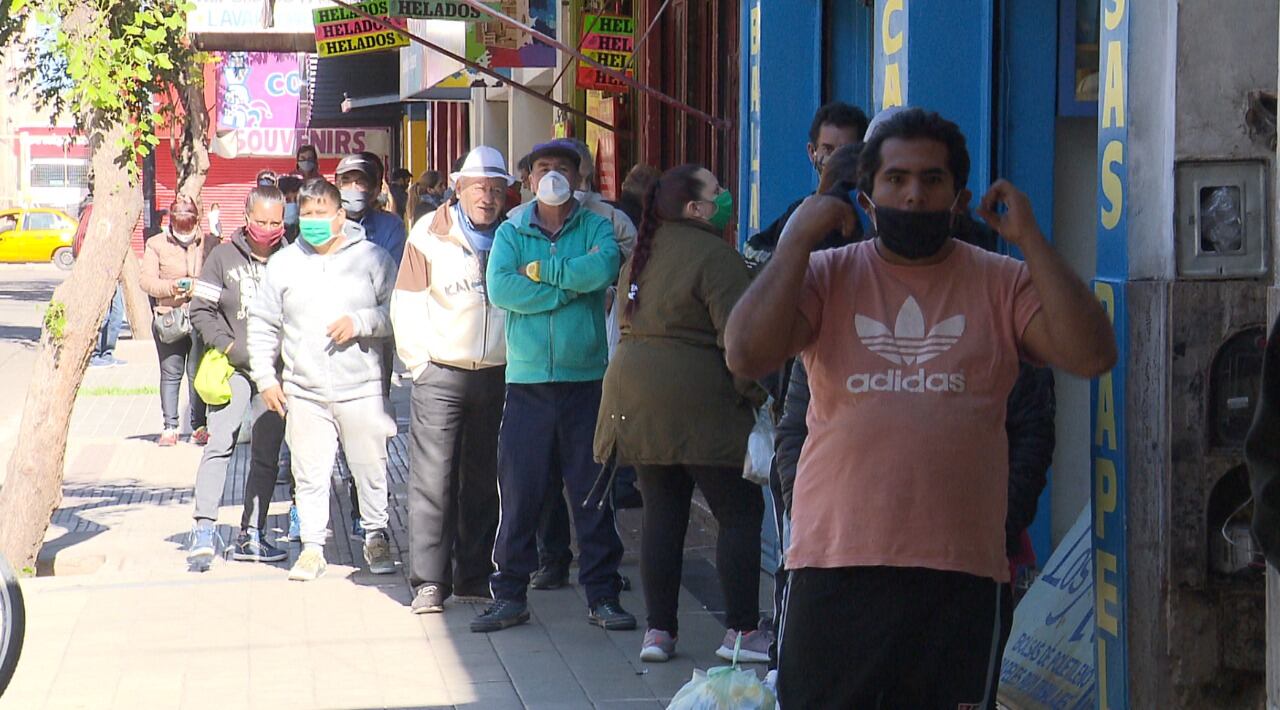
1175, 160, 1270, 279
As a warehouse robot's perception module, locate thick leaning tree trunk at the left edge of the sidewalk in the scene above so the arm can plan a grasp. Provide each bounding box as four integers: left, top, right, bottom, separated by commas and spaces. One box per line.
0, 119, 142, 569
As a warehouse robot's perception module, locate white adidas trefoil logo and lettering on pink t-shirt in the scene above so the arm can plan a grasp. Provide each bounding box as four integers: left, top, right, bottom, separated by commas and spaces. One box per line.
845, 296, 965, 394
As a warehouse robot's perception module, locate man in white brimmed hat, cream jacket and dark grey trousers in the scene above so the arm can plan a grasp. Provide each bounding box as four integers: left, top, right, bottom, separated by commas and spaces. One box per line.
392, 146, 515, 614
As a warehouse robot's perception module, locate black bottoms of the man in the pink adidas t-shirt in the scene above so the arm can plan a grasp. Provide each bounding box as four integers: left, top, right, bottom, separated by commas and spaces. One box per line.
778, 567, 1001, 710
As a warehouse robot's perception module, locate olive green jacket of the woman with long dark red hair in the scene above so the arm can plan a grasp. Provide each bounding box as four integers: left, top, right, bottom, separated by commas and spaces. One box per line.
595, 223, 765, 468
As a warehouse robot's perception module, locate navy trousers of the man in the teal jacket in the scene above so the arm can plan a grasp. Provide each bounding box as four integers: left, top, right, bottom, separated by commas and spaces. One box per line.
490, 380, 622, 606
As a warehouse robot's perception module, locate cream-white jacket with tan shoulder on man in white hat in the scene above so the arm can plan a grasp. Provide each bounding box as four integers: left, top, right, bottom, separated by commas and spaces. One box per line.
392, 203, 507, 380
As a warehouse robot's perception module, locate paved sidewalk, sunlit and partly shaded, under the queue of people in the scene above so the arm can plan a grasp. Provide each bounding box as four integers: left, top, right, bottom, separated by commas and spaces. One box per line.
0, 340, 771, 710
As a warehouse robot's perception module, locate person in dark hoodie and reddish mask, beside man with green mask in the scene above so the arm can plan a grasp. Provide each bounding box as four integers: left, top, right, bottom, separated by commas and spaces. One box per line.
187, 187, 288, 569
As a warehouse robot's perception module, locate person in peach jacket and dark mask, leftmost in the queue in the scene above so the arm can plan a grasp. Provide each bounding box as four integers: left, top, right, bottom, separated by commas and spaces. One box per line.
140, 194, 209, 446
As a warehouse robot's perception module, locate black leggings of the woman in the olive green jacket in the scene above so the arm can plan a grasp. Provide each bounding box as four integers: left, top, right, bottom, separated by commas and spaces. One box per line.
636, 466, 764, 636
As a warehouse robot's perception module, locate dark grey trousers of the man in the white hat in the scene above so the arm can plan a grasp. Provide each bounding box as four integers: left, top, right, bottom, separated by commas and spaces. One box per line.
408, 363, 506, 595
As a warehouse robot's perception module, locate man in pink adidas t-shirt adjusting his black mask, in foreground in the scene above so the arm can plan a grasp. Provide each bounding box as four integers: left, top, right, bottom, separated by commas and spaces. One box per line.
726, 109, 1116, 707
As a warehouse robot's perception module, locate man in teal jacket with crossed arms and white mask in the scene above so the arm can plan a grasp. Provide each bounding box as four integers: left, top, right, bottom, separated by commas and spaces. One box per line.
471, 138, 635, 632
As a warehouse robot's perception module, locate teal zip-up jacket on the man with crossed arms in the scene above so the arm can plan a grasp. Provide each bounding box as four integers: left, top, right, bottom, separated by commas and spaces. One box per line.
485, 205, 620, 384
